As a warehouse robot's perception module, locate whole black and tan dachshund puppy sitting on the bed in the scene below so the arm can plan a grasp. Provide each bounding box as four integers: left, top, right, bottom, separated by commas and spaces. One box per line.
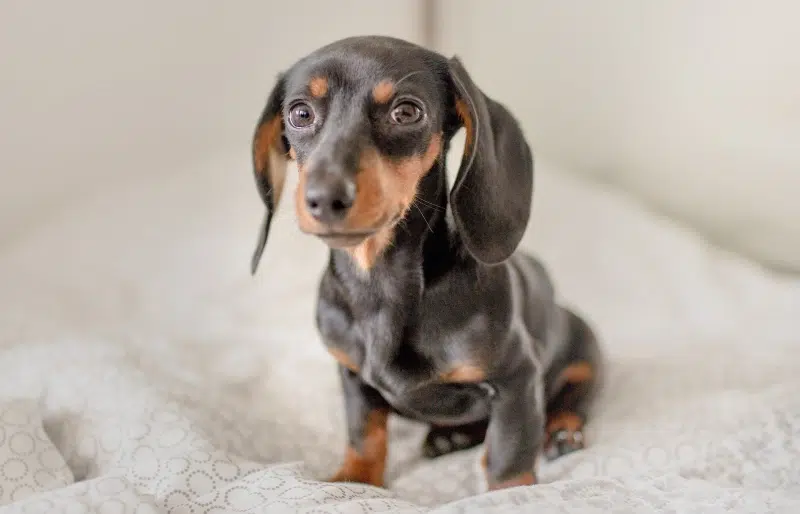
251, 36, 602, 490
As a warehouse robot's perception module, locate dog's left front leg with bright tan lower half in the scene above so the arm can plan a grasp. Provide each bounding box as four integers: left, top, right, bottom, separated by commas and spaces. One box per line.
329, 366, 389, 487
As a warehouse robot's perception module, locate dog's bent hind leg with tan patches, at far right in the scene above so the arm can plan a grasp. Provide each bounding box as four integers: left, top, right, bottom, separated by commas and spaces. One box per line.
544, 310, 602, 460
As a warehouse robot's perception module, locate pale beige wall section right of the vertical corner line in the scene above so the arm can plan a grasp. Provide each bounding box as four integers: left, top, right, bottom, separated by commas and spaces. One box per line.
439, 0, 800, 270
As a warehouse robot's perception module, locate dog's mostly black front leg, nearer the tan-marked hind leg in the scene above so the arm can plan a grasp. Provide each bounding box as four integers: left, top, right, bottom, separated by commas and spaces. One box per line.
483, 365, 545, 490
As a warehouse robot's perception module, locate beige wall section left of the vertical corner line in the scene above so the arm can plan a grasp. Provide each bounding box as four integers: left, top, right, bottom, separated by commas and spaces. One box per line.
0, 0, 420, 244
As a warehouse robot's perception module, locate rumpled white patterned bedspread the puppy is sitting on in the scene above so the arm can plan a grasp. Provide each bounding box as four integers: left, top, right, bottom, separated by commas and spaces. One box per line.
0, 155, 800, 514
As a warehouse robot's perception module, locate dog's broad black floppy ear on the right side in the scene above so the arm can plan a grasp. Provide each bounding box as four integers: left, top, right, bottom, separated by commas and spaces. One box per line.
449, 57, 533, 265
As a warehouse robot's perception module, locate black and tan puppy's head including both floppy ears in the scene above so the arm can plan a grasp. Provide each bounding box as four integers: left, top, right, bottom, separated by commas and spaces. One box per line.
252, 36, 533, 272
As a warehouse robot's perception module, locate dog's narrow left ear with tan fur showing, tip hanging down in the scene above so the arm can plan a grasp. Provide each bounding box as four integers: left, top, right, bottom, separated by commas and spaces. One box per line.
250, 77, 289, 274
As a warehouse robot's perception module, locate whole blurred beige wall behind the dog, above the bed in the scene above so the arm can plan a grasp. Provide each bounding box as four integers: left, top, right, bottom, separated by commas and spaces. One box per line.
0, 0, 800, 271
